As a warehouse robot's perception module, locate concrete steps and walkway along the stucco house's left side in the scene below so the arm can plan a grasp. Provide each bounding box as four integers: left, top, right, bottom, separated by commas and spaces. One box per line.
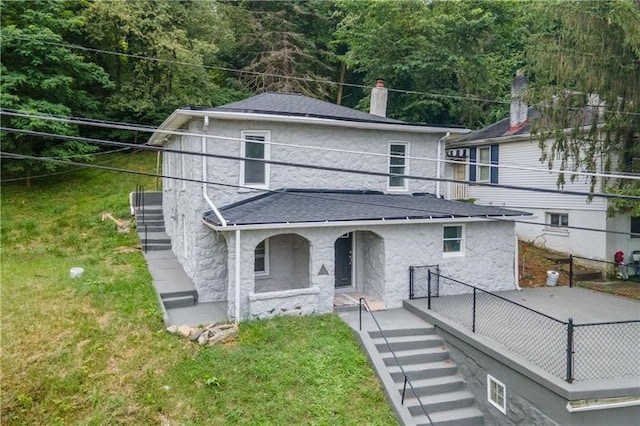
131, 192, 198, 310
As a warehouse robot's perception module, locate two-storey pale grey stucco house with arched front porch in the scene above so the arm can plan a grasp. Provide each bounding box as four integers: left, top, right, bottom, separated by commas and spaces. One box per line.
150, 87, 527, 319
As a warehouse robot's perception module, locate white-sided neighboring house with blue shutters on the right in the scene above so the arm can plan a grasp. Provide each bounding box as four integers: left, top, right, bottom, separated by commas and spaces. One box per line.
445, 76, 640, 262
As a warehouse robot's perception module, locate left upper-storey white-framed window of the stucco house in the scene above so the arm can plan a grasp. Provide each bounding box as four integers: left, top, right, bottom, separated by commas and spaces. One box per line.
240, 131, 269, 186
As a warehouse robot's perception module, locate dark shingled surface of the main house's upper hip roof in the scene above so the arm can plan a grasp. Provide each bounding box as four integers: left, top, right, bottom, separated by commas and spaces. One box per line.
198, 92, 462, 127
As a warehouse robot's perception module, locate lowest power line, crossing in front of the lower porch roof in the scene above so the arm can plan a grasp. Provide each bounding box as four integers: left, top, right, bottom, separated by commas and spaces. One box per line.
0, 151, 640, 237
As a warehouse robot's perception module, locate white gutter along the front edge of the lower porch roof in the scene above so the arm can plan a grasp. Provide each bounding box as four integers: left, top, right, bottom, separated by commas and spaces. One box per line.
202, 214, 531, 231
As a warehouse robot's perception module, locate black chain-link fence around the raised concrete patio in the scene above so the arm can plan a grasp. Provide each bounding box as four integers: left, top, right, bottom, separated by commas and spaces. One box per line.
411, 267, 640, 383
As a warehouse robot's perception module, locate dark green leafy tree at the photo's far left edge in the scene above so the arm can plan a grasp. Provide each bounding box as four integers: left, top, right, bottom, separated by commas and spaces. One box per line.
0, 1, 112, 185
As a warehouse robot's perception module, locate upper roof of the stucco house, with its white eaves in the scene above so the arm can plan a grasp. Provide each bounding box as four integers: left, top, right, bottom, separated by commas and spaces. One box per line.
149, 93, 469, 145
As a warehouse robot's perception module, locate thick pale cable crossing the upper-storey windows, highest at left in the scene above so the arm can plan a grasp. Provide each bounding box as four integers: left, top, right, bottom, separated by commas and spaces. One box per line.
0, 109, 640, 180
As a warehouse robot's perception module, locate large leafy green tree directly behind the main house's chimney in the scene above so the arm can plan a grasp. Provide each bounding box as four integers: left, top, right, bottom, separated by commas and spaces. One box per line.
336, 0, 528, 128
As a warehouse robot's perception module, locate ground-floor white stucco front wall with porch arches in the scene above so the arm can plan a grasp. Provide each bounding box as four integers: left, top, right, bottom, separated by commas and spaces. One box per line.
215, 222, 515, 318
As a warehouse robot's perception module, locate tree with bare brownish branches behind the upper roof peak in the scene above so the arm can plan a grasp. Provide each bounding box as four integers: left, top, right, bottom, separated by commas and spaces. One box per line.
230, 0, 338, 98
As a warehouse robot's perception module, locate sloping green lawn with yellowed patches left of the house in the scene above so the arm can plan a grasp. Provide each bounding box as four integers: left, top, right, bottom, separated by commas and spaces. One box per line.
1, 153, 396, 425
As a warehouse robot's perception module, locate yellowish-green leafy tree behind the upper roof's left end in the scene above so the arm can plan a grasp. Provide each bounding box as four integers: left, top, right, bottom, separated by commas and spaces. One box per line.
84, 0, 244, 125
